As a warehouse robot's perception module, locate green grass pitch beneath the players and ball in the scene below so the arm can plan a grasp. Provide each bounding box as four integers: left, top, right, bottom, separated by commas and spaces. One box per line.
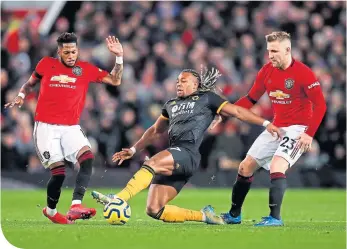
1, 189, 346, 249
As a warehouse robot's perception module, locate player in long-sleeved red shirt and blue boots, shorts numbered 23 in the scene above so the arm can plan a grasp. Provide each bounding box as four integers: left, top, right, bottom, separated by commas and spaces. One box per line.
222, 31, 326, 226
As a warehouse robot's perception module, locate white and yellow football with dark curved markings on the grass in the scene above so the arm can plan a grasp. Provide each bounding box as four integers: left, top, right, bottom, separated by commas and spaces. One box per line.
104, 197, 131, 225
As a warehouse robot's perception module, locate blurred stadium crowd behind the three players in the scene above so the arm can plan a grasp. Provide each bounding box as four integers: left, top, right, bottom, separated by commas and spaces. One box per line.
1, 1, 346, 188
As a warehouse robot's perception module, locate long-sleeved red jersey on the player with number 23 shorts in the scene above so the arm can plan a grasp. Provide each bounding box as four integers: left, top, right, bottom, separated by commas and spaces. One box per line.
235, 59, 326, 136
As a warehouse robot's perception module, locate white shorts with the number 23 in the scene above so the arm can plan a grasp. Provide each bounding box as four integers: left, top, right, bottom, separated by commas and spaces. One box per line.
247, 125, 306, 170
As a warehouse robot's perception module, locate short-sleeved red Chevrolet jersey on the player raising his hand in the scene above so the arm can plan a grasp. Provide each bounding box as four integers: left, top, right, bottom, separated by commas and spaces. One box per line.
32, 57, 108, 125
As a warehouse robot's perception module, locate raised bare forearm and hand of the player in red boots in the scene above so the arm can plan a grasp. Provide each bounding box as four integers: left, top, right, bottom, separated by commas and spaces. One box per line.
102, 36, 123, 86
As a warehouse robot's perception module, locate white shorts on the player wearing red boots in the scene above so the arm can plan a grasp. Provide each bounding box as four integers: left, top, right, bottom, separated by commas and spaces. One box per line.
33, 121, 91, 168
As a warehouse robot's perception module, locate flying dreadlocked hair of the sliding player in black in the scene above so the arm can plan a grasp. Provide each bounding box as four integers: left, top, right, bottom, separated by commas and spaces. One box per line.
182, 66, 222, 91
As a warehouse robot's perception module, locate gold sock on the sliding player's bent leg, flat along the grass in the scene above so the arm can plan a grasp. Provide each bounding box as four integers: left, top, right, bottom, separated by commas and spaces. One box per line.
158, 205, 203, 222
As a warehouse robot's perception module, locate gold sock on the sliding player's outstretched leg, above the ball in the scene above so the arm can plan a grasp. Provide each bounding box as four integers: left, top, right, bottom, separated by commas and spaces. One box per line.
117, 165, 155, 201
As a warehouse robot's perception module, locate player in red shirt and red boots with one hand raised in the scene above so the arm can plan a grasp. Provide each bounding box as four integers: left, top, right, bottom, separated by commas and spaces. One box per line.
5, 32, 123, 224
